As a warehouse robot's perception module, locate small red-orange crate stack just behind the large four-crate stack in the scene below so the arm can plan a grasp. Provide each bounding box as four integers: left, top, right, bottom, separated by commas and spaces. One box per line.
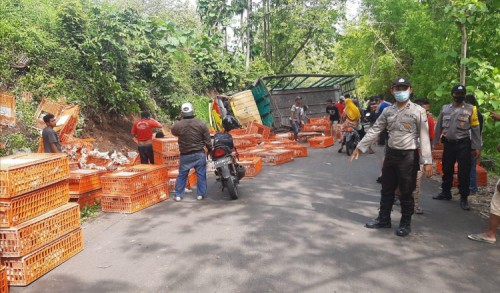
69, 169, 105, 208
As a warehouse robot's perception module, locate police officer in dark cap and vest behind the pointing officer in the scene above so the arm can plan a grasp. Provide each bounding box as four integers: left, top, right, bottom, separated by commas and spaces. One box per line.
432, 84, 481, 210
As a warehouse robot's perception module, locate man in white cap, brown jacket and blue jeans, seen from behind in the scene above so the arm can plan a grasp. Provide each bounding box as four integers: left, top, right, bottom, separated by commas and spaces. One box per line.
172, 103, 212, 201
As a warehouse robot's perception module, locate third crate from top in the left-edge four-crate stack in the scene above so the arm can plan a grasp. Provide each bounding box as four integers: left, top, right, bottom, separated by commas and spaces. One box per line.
0, 203, 80, 257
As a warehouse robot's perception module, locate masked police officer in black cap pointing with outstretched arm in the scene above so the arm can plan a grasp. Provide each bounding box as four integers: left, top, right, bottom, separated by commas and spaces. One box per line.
351, 78, 432, 237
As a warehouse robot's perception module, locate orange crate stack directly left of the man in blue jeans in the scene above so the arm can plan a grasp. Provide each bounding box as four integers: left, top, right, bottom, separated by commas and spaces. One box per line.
153, 137, 181, 169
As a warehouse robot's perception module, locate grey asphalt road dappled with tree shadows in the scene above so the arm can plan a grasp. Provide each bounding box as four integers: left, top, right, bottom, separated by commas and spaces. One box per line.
11, 146, 500, 293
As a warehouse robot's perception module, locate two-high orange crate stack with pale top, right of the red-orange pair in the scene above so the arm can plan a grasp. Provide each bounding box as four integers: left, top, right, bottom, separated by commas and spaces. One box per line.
101, 165, 168, 213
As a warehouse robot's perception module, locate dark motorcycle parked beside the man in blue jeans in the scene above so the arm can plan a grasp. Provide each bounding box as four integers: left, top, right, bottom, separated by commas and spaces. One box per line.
211, 133, 246, 200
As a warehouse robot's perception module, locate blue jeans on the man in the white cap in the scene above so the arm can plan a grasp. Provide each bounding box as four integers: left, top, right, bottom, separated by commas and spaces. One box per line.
175, 152, 207, 198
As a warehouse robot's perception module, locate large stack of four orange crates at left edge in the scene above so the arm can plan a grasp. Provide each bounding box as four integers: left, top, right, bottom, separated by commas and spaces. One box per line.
0, 154, 83, 286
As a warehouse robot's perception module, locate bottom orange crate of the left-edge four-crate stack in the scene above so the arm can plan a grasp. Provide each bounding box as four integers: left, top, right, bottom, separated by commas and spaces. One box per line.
2, 228, 83, 286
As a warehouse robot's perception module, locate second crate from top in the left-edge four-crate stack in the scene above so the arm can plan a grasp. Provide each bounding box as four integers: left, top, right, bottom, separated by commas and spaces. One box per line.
0, 180, 69, 228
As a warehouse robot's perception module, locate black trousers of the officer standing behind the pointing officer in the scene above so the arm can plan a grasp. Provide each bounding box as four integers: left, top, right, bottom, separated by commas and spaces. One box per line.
441, 139, 471, 200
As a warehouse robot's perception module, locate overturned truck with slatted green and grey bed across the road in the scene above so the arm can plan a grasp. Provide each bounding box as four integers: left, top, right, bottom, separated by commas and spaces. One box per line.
210, 74, 361, 131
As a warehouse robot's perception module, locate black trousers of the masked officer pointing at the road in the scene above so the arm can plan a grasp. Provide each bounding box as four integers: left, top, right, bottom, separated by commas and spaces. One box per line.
379, 148, 420, 223
